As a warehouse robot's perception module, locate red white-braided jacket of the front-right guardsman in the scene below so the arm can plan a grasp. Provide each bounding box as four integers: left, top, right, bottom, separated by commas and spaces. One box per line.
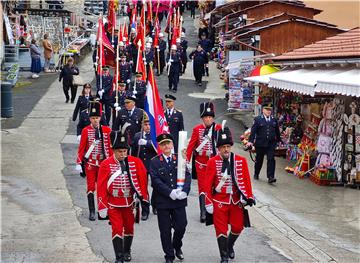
205, 154, 254, 204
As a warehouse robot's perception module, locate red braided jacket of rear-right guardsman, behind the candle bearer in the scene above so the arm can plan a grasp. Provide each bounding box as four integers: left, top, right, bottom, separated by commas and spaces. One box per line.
186, 124, 221, 164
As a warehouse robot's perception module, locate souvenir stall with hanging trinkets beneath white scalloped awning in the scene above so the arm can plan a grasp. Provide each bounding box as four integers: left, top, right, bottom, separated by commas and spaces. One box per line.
246, 68, 360, 187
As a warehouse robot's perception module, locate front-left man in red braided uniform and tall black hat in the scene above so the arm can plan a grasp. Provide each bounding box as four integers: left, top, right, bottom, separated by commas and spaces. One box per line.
97, 129, 148, 263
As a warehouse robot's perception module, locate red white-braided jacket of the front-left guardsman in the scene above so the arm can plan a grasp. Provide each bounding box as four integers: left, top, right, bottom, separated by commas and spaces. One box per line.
97, 155, 149, 211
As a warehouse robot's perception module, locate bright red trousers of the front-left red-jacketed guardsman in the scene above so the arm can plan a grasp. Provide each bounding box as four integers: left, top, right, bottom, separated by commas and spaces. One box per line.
108, 205, 135, 238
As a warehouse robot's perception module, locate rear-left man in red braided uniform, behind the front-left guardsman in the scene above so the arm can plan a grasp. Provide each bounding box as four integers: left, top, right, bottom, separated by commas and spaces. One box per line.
76, 101, 112, 221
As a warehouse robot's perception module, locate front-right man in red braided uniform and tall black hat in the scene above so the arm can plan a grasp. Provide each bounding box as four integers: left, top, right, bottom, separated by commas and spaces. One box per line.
205, 123, 255, 263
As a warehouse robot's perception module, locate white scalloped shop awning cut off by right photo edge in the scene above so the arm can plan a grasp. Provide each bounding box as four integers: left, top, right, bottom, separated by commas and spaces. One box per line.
315, 68, 360, 97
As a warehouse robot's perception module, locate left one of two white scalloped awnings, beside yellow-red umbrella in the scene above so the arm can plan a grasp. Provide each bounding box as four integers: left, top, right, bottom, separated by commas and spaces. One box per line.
269, 68, 342, 96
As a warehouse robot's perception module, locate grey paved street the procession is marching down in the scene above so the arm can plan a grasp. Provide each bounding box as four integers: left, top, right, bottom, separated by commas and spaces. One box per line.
1, 7, 360, 263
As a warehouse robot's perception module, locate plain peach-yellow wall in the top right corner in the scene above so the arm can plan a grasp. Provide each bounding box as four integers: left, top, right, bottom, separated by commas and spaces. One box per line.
303, 0, 360, 29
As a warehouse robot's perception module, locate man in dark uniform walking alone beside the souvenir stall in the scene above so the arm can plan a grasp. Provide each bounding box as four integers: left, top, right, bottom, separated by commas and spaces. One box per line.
247, 104, 281, 184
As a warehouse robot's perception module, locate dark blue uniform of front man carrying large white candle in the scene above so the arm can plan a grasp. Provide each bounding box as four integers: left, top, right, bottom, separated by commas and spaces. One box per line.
150, 154, 191, 260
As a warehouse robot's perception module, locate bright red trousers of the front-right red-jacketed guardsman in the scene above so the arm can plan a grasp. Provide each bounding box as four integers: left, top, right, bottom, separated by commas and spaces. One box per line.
213, 202, 244, 237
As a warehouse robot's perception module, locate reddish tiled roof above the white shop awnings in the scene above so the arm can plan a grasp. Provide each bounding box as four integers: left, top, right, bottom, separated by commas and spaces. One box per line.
272, 27, 360, 60
